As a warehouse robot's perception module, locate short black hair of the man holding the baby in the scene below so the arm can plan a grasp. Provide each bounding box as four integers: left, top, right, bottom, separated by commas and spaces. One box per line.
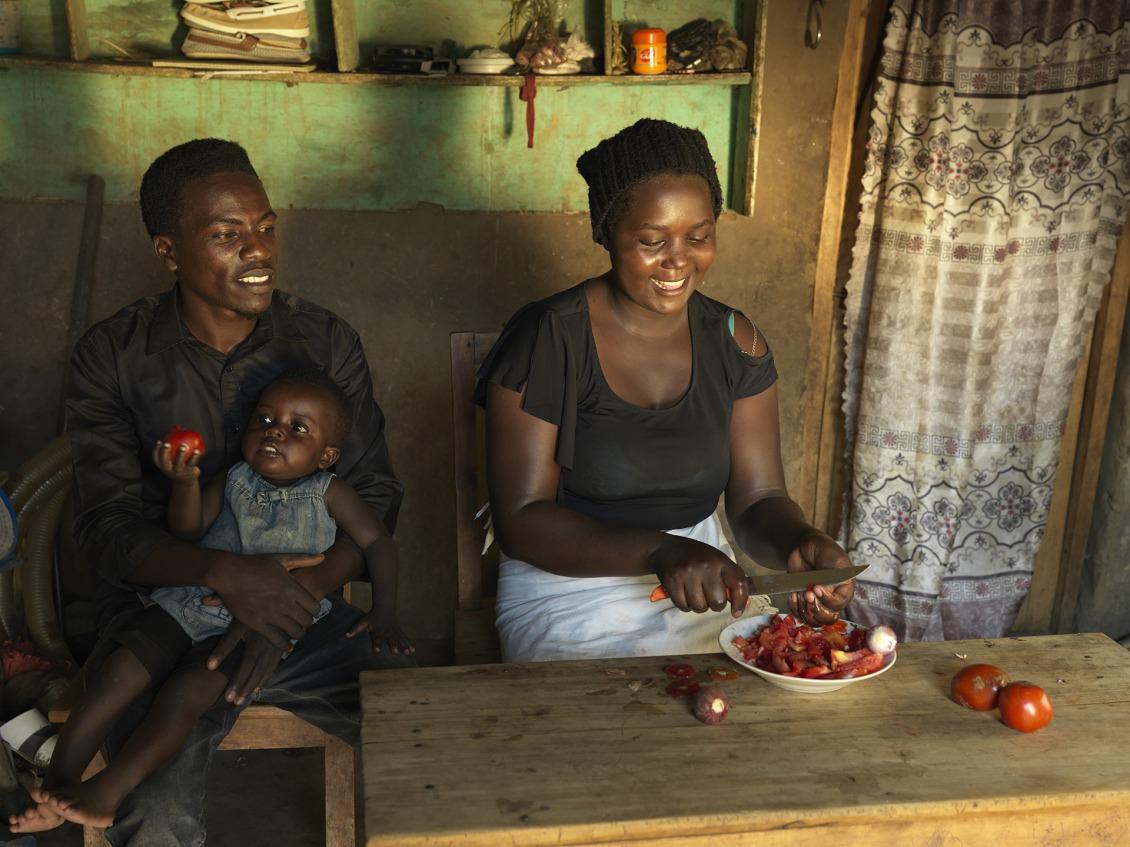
140, 138, 259, 238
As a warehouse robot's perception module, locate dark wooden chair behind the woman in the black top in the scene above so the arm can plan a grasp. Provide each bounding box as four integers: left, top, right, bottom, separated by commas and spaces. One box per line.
451, 332, 501, 665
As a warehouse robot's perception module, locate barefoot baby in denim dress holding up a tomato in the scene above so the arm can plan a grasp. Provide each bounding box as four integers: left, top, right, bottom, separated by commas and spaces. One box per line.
11, 370, 414, 832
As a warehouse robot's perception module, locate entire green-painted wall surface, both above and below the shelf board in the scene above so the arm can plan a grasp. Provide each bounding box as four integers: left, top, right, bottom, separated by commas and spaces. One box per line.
0, 0, 749, 211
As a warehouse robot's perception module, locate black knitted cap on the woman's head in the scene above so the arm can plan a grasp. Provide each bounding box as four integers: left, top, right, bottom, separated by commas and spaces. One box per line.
576, 117, 722, 247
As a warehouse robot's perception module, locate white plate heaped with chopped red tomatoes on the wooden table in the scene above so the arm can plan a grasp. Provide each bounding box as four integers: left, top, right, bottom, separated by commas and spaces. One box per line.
719, 614, 896, 693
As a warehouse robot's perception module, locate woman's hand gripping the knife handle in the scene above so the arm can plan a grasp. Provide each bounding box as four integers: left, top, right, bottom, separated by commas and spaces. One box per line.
647, 533, 749, 618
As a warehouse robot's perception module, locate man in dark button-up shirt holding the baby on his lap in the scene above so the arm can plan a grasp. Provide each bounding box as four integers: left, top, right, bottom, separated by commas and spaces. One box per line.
28, 139, 411, 847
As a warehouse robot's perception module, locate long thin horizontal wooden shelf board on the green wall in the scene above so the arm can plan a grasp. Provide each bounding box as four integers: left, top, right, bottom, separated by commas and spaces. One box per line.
0, 55, 751, 88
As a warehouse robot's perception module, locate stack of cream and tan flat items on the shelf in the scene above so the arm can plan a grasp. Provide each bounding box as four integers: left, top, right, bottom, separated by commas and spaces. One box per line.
181, 0, 310, 64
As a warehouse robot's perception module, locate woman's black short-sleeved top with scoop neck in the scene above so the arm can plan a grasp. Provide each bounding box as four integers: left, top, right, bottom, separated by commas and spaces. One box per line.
476, 282, 776, 530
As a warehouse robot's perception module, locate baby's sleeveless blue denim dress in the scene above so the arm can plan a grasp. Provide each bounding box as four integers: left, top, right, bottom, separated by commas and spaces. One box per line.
149, 462, 338, 644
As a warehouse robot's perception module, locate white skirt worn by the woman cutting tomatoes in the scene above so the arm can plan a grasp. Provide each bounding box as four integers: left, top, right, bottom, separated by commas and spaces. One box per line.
496, 515, 772, 662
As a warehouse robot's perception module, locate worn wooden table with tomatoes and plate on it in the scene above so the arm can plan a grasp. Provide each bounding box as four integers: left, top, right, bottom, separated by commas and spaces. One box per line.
362, 635, 1130, 847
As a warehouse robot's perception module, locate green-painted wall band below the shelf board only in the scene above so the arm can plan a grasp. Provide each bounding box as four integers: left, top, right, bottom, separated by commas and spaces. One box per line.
0, 68, 748, 211
